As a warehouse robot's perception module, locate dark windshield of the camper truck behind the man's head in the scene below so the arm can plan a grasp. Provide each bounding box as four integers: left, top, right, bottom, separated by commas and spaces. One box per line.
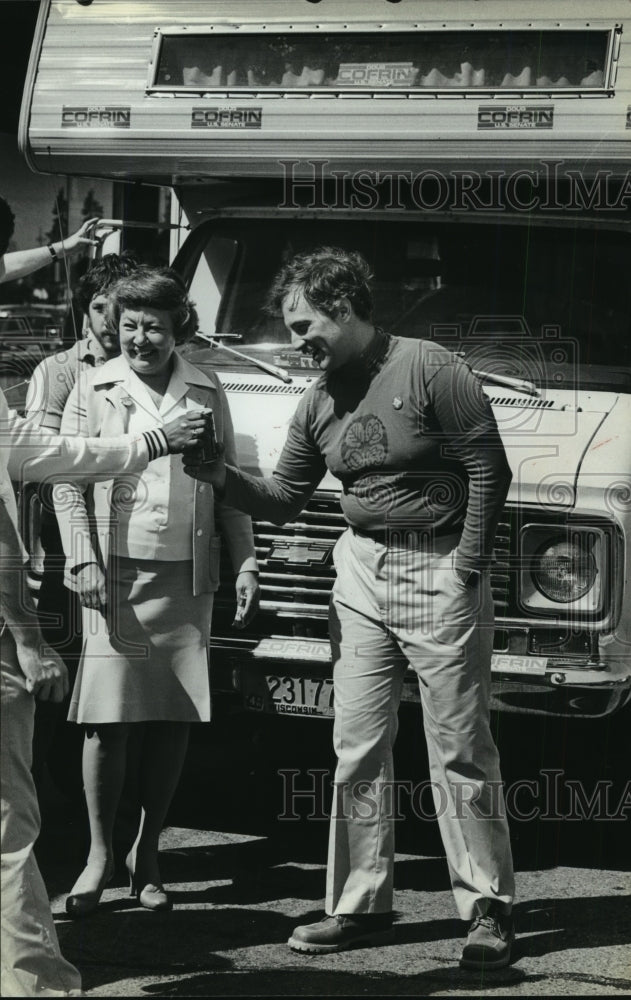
183, 213, 631, 391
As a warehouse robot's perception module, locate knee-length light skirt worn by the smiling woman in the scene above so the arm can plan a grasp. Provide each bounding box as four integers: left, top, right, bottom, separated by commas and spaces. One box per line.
68, 556, 213, 724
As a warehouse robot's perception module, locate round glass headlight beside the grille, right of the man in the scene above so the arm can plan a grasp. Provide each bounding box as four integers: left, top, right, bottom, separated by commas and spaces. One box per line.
531, 538, 598, 603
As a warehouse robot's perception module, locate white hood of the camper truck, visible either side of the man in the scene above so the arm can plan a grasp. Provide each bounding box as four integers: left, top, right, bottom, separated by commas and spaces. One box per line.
218, 372, 617, 508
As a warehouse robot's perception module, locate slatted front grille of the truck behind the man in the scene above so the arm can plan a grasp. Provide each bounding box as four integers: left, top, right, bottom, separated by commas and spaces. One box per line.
218, 493, 515, 634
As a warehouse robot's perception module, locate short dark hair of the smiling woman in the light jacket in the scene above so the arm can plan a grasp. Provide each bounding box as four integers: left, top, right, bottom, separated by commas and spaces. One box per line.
107, 264, 198, 344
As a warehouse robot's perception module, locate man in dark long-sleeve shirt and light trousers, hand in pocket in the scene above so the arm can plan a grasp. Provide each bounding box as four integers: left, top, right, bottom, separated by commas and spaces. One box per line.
189, 248, 514, 968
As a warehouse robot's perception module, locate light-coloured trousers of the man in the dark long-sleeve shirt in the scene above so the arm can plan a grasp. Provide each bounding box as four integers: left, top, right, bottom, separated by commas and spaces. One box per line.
326, 530, 514, 920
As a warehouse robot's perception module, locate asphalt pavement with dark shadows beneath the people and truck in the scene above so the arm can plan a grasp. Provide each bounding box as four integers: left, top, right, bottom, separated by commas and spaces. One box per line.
38, 707, 631, 997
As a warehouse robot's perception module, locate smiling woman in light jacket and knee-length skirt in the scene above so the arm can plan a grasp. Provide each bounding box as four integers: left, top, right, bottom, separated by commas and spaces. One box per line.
56, 266, 258, 917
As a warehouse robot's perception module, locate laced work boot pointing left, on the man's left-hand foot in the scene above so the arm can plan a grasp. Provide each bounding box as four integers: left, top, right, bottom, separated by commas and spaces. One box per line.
287, 913, 394, 955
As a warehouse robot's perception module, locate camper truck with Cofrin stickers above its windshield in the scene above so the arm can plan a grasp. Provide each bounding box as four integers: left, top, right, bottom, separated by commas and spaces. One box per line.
20, 0, 631, 725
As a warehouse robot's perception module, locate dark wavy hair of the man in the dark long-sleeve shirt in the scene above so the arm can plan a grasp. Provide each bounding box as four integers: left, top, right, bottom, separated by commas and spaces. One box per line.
265, 247, 372, 320
